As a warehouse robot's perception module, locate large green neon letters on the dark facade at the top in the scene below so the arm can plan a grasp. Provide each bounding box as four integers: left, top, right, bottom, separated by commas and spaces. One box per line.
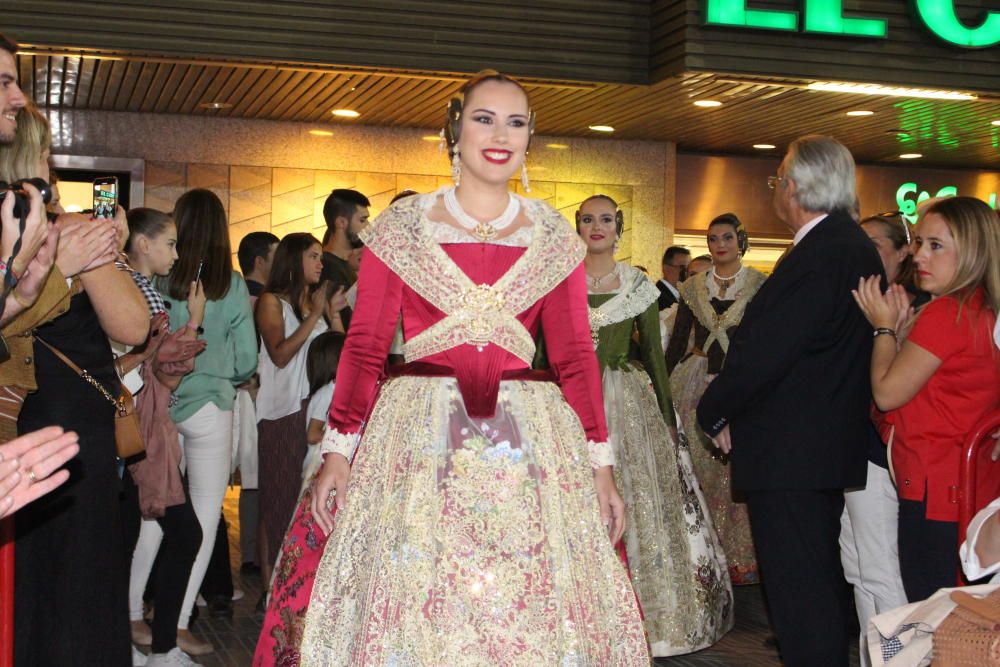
703, 0, 1000, 48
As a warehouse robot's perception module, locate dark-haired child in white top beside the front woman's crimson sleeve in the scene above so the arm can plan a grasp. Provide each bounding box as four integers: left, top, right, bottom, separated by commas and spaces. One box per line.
302, 331, 347, 488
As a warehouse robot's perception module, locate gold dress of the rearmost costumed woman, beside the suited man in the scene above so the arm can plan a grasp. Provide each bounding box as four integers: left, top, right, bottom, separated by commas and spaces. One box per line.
666, 267, 765, 584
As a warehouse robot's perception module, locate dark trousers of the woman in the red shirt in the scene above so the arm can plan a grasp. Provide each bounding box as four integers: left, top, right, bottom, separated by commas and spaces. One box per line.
899, 498, 958, 602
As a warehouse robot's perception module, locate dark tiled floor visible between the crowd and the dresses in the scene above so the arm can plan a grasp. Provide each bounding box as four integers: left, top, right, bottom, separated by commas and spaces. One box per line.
145, 492, 859, 667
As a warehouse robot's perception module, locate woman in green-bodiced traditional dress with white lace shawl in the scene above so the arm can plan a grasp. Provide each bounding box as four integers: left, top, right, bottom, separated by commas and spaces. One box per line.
576, 195, 733, 657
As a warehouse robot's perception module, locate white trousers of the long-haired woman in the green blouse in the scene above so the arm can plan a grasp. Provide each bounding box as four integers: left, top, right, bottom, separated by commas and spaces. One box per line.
178, 403, 233, 630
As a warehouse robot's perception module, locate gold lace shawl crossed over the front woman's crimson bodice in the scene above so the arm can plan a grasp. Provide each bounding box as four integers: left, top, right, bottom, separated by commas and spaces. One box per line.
363, 191, 586, 366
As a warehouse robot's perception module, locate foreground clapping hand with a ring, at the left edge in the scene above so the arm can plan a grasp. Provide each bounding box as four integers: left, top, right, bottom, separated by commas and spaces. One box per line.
0, 426, 80, 517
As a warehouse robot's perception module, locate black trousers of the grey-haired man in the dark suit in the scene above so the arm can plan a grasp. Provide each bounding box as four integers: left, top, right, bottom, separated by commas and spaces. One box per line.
746, 489, 850, 667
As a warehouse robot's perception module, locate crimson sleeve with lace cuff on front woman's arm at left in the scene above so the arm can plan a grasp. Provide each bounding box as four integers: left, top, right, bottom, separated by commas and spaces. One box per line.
320, 250, 403, 460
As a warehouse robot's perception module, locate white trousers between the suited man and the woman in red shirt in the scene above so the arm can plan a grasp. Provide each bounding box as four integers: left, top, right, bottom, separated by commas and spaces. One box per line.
840, 461, 907, 667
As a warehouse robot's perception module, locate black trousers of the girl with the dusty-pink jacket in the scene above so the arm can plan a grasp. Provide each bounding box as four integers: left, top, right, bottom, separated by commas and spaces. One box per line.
122, 470, 202, 653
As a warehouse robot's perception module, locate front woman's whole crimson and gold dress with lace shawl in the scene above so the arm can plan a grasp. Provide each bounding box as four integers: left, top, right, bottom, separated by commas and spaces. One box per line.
301, 192, 649, 667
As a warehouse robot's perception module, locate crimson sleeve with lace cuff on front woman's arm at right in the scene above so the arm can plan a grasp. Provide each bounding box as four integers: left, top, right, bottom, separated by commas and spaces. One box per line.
542, 264, 615, 468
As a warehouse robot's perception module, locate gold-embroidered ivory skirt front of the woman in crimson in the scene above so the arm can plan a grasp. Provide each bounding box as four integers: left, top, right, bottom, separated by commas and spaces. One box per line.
301, 377, 649, 667
